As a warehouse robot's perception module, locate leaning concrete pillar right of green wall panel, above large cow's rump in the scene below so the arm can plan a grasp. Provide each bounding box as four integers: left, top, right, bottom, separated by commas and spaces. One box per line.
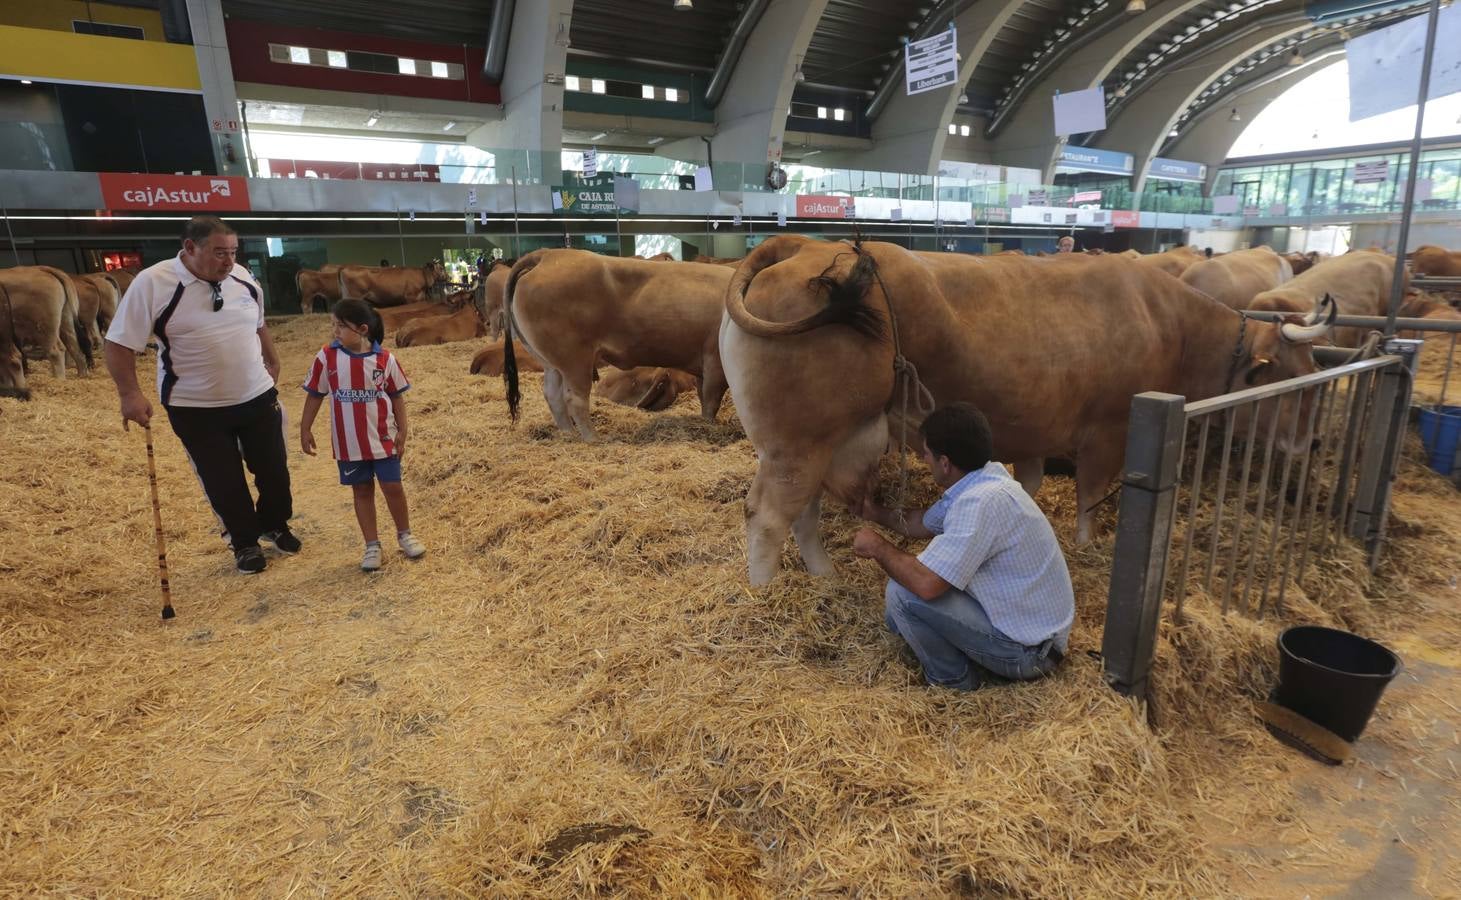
659, 0, 827, 173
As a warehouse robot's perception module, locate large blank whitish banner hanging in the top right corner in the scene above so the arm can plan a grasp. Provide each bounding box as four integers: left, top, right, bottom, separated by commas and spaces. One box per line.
1344, 6, 1461, 121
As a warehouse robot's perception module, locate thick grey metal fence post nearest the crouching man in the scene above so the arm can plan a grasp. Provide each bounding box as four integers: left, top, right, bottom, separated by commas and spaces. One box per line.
1102, 392, 1186, 697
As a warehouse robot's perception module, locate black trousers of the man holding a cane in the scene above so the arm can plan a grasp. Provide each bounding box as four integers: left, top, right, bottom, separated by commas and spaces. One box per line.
167, 387, 294, 551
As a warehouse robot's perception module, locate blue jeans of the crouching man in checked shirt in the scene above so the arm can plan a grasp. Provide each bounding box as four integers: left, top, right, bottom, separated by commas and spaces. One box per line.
884, 579, 1056, 691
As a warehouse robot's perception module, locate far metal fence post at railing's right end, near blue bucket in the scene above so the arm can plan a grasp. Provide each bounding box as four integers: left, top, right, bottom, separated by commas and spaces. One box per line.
1350, 338, 1423, 570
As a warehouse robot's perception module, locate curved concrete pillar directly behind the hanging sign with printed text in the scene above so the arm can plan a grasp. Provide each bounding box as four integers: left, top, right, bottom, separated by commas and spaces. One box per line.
830, 0, 1021, 175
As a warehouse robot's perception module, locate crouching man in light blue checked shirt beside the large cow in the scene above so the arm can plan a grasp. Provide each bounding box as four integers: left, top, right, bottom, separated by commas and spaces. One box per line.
852, 403, 1075, 691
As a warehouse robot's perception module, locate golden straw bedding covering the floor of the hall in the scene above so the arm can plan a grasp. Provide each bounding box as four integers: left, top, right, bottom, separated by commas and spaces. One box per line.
0, 317, 1454, 897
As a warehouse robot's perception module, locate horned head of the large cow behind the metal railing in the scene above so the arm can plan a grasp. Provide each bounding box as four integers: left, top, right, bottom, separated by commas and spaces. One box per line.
1232, 294, 1338, 453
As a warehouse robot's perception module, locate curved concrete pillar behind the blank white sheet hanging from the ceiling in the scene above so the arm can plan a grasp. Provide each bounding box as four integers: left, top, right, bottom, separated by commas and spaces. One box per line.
991, 0, 1202, 184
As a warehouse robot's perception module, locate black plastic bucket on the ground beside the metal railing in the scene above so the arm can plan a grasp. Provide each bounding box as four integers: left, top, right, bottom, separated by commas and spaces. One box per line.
1273, 625, 1401, 742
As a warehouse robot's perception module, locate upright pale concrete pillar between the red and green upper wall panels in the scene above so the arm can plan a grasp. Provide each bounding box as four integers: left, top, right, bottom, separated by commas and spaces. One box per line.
466, 0, 573, 181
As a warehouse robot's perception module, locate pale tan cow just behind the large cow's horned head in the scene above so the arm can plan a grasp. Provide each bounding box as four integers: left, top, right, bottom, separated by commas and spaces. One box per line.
1248, 250, 1410, 346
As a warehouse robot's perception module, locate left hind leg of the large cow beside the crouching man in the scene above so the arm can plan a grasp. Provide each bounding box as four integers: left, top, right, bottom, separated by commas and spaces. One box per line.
745, 451, 831, 586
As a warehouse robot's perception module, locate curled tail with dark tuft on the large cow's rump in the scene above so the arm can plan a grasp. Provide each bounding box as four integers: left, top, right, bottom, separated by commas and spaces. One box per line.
726, 235, 884, 339
